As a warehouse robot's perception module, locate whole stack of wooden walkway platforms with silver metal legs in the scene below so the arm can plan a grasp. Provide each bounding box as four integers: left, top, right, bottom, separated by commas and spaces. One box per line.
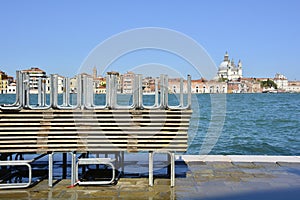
0, 71, 191, 189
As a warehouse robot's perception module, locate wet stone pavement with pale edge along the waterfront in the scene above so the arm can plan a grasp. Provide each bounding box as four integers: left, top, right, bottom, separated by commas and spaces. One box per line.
0, 155, 300, 200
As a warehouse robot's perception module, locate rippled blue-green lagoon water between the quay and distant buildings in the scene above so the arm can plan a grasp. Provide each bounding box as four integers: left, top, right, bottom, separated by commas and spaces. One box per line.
0, 93, 300, 156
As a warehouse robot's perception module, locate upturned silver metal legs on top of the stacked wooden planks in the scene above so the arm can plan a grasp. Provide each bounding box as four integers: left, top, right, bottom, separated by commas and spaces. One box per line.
0, 71, 191, 110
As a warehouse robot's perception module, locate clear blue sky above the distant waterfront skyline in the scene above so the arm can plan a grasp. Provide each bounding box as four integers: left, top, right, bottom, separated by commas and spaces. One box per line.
0, 0, 300, 80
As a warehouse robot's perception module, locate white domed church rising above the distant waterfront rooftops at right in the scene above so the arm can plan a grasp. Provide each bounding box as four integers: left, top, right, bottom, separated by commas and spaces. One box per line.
217, 52, 243, 81
